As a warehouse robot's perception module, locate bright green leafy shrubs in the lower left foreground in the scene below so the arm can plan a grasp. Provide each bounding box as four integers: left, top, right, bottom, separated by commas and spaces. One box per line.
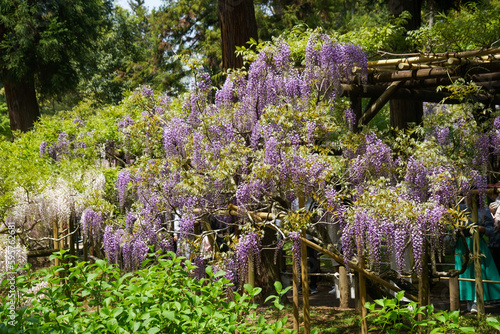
0, 251, 293, 333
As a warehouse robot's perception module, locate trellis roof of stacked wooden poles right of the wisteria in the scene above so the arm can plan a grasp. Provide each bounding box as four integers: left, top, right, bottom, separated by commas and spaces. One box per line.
341, 47, 500, 124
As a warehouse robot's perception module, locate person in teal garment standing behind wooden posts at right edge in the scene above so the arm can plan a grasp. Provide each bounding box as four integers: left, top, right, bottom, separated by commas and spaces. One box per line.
455, 204, 500, 313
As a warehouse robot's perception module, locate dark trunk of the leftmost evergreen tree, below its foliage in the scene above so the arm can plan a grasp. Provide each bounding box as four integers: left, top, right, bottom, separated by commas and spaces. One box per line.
3, 76, 40, 132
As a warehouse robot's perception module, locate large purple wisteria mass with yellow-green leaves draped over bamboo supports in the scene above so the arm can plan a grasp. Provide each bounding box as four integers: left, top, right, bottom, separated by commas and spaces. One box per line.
93, 34, 480, 279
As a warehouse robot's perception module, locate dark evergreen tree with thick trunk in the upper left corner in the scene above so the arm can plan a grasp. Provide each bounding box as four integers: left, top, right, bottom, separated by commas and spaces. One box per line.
0, 0, 112, 131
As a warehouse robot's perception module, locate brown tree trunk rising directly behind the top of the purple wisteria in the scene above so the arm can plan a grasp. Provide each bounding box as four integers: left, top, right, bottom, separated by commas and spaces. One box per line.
219, 0, 258, 70
